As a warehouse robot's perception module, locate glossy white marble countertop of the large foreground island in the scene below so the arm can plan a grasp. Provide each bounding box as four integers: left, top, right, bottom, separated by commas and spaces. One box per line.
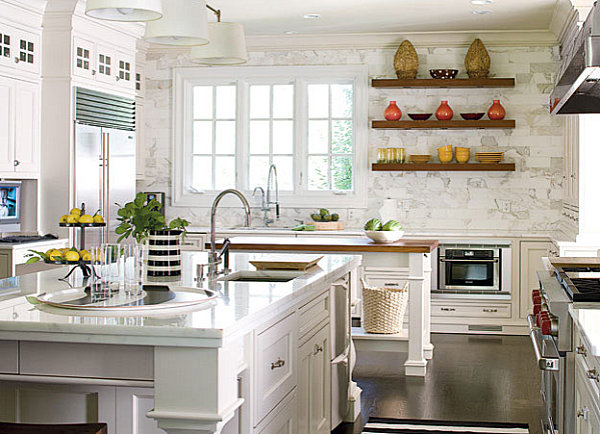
0, 252, 360, 346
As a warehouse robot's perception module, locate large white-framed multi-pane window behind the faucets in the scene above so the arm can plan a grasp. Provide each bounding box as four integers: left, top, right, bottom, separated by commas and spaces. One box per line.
173, 66, 367, 207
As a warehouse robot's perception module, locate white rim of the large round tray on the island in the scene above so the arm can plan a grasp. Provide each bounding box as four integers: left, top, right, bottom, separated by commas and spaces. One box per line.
28, 286, 218, 312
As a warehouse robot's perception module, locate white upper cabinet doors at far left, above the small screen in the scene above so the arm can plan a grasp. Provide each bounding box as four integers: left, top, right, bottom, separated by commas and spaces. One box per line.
0, 77, 41, 178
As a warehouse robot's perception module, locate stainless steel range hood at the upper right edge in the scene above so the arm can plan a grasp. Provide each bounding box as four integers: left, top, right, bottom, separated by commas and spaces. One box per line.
550, 2, 600, 115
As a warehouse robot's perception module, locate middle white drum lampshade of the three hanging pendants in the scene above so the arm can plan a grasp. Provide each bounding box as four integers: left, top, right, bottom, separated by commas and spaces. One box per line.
144, 0, 209, 45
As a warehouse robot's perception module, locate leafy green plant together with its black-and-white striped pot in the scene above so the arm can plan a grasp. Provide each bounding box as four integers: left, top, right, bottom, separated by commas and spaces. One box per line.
115, 193, 190, 277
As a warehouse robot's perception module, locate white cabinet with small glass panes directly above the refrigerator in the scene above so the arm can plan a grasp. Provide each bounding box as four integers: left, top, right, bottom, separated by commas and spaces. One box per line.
72, 36, 135, 91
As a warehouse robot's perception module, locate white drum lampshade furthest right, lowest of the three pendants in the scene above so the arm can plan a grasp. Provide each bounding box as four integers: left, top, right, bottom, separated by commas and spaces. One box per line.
190, 22, 248, 65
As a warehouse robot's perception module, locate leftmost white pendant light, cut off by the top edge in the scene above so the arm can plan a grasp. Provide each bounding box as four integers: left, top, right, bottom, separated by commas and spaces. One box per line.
85, 0, 163, 21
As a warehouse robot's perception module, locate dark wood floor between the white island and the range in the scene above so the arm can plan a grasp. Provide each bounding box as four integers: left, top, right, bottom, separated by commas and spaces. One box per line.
333, 334, 541, 434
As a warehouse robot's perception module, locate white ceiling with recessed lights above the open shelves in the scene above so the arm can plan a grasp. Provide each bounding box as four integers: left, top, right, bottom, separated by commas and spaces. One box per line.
209, 0, 559, 35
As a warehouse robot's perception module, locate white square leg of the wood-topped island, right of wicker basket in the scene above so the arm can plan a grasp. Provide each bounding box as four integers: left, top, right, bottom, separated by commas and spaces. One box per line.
404, 253, 430, 377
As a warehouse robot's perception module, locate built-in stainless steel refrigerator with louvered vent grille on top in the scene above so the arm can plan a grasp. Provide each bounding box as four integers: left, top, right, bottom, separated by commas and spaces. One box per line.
75, 89, 136, 247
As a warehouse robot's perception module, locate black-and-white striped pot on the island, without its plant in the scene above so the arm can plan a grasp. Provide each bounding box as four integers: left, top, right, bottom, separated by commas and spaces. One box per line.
147, 230, 181, 277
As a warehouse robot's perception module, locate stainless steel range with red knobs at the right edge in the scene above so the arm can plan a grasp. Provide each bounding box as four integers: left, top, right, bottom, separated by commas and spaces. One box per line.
527, 266, 600, 434
